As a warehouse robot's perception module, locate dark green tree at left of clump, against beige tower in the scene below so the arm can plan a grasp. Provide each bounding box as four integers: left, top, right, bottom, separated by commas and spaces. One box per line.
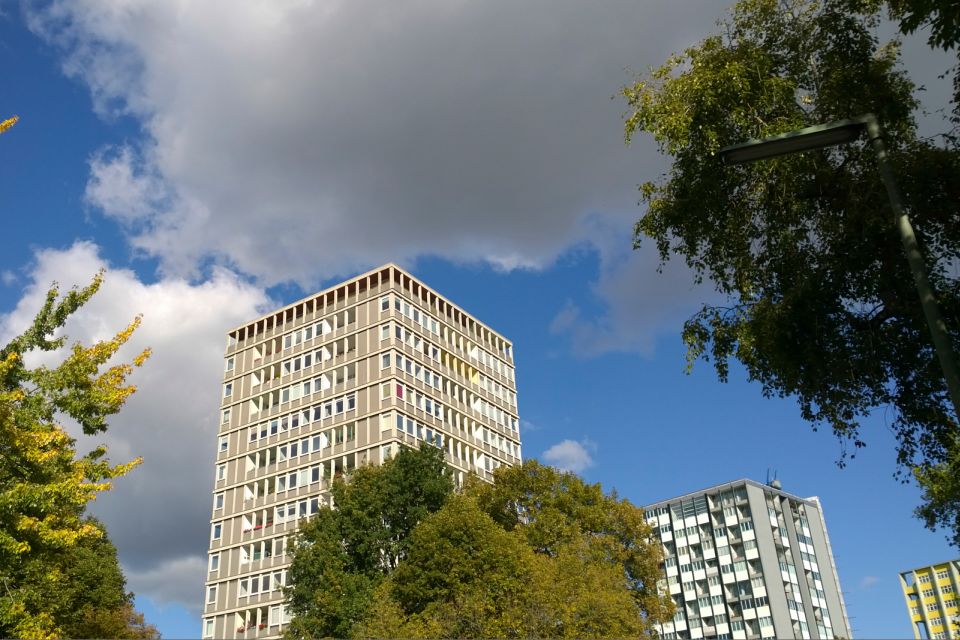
286, 444, 453, 638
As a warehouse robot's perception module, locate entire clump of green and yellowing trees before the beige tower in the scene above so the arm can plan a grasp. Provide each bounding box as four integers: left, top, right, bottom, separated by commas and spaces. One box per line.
287, 452, 673, 638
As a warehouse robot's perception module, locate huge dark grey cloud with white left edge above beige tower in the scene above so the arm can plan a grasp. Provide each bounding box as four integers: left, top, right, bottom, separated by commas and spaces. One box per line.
28, 0, 728, 286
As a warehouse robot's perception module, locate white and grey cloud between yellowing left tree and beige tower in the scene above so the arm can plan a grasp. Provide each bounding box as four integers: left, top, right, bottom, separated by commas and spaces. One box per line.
0, 242, 275, 610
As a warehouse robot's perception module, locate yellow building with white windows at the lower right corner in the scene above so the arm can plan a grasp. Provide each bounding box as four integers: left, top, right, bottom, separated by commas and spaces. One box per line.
900, 560, 960, 640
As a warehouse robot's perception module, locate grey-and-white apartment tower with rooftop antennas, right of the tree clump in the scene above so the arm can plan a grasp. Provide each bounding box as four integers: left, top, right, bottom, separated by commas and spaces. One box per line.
646, 480, 851, 640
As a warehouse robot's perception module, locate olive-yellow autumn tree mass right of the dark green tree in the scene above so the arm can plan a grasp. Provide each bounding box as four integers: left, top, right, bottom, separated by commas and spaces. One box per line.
353, 461, 673, 638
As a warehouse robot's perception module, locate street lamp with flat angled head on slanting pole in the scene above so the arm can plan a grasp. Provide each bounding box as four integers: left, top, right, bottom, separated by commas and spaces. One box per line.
720, 114, 960, 420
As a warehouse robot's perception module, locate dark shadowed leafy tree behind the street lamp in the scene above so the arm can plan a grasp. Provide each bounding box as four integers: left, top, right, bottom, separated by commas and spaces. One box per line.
623, 0, 960, 544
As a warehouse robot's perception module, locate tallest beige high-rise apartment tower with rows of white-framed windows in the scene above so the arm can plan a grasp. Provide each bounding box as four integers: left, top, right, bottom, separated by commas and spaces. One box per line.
202, 264, 521, 638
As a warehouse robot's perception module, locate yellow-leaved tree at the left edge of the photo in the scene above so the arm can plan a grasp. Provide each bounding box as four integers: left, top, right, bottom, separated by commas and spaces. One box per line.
0, 274, 149, 638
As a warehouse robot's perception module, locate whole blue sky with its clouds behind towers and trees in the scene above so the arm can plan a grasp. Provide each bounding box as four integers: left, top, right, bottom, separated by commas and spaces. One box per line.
0, 0, 956, 638
